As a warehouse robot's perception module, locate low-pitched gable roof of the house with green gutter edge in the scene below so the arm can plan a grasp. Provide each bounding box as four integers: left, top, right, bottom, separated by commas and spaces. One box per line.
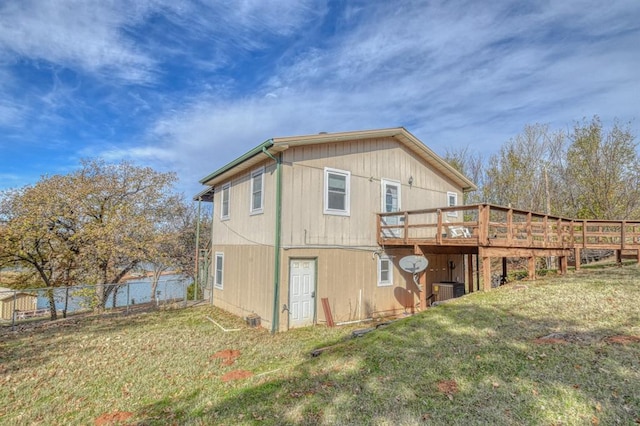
196, 127, 477, 196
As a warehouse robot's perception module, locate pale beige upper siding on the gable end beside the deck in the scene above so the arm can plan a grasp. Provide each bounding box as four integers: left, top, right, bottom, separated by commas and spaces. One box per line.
282, 138, 462, 247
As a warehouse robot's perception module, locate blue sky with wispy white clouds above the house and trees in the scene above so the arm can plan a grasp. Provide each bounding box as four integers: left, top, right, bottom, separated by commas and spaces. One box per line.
0, 0, 640, 195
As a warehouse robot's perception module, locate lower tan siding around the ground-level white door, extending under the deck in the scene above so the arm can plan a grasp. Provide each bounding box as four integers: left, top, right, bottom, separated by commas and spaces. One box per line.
280, 248, 464, 330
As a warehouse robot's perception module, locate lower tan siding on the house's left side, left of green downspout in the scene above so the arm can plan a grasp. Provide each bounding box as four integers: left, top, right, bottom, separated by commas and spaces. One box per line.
211, 245, 274, 327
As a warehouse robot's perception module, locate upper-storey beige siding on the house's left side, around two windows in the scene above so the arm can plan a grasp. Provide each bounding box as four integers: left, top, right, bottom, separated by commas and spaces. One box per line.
212, 161, 276, 246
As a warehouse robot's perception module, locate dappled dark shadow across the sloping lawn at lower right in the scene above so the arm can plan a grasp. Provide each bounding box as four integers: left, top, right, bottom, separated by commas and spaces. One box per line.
137, 292, 640, 425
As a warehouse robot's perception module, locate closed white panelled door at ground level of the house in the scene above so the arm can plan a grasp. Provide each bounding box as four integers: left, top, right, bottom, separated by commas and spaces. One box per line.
289, 259, 316, 328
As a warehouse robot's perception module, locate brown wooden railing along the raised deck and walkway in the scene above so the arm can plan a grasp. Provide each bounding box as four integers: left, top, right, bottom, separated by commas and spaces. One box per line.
377, 204, 640, 250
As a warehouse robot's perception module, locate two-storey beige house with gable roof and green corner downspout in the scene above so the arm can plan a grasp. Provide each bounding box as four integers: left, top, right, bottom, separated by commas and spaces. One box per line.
197, 127, 476, 332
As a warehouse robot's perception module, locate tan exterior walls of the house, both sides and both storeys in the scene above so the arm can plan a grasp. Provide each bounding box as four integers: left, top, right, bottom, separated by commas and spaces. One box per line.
211, 138, 465, 330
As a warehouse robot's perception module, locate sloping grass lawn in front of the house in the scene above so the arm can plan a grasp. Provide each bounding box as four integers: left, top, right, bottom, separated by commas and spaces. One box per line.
0, 266, 640, 425
